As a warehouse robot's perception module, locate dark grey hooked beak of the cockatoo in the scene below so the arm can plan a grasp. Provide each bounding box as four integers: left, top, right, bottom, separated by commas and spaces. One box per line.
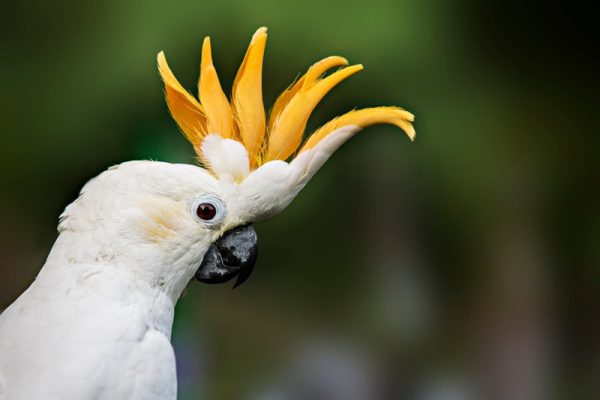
196, 225, 258, 288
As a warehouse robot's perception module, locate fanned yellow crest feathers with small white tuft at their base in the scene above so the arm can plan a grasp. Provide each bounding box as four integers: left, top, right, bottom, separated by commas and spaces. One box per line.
158, 27, 415, 181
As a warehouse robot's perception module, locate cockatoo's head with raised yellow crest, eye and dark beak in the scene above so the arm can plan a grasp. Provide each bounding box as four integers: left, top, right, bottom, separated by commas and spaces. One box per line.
61, 28, 415, 292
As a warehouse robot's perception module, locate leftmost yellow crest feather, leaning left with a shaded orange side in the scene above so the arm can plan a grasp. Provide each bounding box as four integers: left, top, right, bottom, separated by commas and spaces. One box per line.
157, 51, 206, 148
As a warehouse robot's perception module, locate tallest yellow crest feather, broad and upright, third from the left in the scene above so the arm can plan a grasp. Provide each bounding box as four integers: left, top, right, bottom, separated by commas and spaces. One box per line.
231, 27, 267, 165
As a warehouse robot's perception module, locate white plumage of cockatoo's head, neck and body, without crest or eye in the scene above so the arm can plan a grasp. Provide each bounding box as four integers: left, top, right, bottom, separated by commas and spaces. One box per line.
0, 162, 223, 400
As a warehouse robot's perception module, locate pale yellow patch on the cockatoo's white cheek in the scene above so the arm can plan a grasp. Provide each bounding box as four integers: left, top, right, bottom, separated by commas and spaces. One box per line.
139, 197, 187, 243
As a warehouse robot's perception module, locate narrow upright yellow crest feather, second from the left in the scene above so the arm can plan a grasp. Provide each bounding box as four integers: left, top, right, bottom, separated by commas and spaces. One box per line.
198, 37, 235, 139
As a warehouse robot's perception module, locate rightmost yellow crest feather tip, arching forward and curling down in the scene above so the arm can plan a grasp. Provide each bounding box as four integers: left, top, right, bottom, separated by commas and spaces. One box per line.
300, 107, 415, 153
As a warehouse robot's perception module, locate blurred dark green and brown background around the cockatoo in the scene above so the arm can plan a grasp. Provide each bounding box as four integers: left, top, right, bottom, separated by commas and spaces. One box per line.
0, 0, 600, 400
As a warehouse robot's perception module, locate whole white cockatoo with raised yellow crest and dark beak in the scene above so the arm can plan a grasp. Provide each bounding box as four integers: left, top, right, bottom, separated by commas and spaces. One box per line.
0, 28, 415, 400
